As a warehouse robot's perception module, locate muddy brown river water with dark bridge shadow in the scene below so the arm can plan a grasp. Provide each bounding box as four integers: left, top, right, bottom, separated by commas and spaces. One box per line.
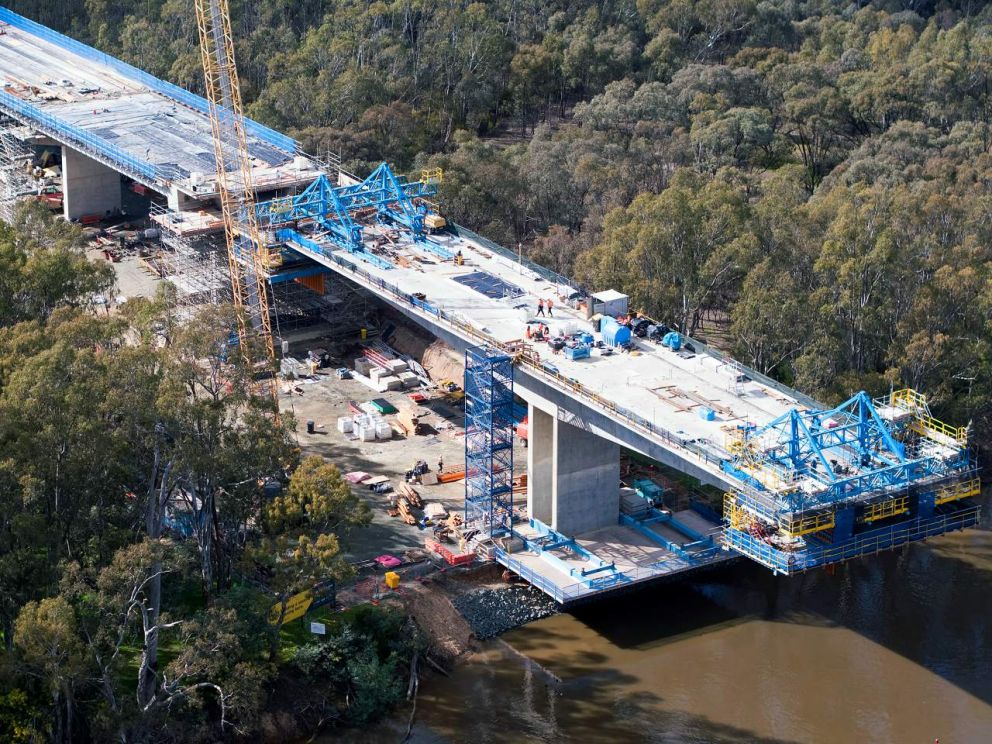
344, 494, 992, 744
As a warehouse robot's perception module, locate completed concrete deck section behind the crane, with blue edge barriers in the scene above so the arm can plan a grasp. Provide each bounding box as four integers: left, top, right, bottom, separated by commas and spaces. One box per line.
0, 7, 318, 198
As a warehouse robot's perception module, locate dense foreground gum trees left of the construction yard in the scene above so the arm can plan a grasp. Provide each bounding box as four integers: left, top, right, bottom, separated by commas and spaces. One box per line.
0, 202, 400, 742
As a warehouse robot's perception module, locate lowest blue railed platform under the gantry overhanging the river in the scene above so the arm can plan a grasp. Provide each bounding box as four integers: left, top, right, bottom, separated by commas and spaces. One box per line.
723, 506, 980, 574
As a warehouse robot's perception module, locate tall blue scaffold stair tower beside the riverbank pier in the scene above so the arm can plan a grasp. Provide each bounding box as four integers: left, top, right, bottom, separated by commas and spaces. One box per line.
465, 346, 513, 537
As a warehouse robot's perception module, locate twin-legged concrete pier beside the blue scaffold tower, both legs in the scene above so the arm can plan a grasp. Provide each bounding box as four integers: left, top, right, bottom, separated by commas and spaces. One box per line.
527, 404, 620, 536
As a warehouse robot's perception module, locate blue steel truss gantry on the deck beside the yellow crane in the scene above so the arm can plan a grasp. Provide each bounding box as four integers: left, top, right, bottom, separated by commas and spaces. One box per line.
255, 163, 453, 269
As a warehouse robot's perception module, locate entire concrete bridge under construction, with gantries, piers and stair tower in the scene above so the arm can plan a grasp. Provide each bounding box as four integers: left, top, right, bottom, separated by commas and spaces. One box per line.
0, 8, 979, 604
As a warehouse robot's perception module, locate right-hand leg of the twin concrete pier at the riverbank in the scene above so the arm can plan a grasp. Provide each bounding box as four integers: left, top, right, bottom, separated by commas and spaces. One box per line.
551, 417, 620, 536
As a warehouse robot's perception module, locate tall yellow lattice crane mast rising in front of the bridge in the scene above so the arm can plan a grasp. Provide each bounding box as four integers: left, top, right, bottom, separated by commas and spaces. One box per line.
195, 0, 278, 404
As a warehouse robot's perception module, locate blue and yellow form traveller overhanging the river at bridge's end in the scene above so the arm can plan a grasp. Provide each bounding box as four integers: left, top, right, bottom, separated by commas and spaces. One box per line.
722, 390, 981, 574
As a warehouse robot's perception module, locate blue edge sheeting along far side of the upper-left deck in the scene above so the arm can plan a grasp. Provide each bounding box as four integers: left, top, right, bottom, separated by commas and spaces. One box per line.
0, 7, 300, 177
